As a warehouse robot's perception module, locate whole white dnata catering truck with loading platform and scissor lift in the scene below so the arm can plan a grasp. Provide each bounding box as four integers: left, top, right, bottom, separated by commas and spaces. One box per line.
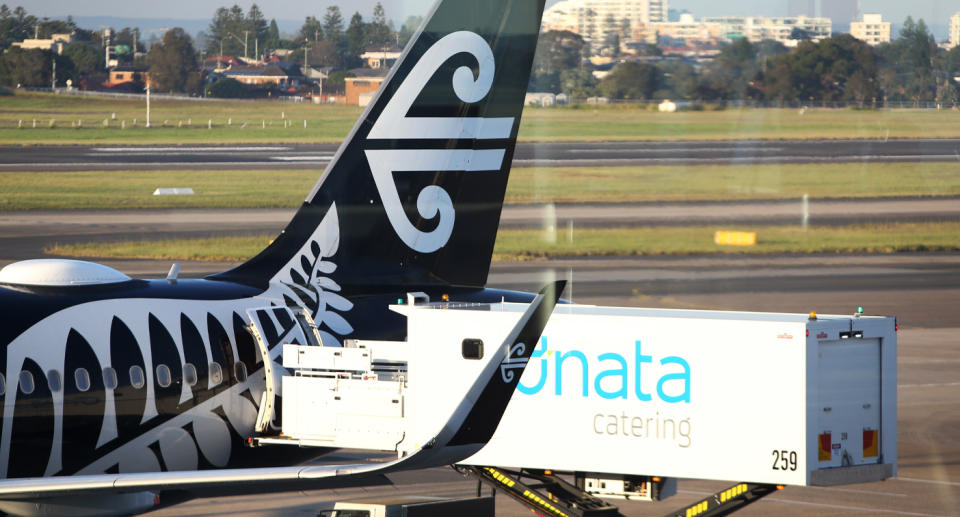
251, 295, 897, 515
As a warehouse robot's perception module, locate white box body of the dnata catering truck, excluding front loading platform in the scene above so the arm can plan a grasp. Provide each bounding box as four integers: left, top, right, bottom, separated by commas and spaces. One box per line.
392, 304, 896, 485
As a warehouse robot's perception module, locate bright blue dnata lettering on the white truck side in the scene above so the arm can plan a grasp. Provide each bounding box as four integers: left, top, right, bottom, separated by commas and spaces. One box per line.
517, 336, 690, 404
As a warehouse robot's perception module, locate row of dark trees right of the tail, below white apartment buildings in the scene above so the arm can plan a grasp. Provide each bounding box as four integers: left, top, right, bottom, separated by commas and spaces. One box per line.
531, 18, 960, 105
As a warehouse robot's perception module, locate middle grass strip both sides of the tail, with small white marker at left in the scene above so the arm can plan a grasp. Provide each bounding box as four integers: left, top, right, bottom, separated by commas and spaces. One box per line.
0, 162, 960, 210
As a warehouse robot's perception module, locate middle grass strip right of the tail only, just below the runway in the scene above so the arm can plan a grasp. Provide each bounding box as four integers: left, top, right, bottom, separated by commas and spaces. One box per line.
507, 162, 960, 203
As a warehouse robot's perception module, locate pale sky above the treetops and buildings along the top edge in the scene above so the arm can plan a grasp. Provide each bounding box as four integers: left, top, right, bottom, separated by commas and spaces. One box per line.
18, 0, 960, 37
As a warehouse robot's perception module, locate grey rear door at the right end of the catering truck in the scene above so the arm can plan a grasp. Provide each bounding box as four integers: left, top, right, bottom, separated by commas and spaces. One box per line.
817, 338, 883, 468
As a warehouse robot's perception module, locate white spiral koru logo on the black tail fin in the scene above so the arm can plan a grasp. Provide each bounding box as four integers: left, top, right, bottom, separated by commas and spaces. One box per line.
365, 31, 514, 253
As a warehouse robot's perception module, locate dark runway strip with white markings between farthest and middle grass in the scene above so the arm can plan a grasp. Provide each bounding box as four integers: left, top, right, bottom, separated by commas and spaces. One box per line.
0, 139, 960, 171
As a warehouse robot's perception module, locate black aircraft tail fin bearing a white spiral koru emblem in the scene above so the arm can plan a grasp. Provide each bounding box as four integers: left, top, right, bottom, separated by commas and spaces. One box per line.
214, 0, 544, 292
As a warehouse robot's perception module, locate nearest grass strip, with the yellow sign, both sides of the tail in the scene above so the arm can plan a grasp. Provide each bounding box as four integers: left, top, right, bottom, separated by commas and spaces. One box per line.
46, 223, 960, 261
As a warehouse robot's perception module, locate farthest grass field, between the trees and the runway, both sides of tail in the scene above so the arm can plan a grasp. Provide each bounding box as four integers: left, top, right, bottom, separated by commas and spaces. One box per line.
0, 92, 960, 145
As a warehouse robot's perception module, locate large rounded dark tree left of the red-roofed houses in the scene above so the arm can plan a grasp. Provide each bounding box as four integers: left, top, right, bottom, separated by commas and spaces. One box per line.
148, 27, 200, 93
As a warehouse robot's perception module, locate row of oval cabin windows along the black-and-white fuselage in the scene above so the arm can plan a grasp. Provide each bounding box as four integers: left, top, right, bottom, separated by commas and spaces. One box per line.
0, 362, 234, 396
